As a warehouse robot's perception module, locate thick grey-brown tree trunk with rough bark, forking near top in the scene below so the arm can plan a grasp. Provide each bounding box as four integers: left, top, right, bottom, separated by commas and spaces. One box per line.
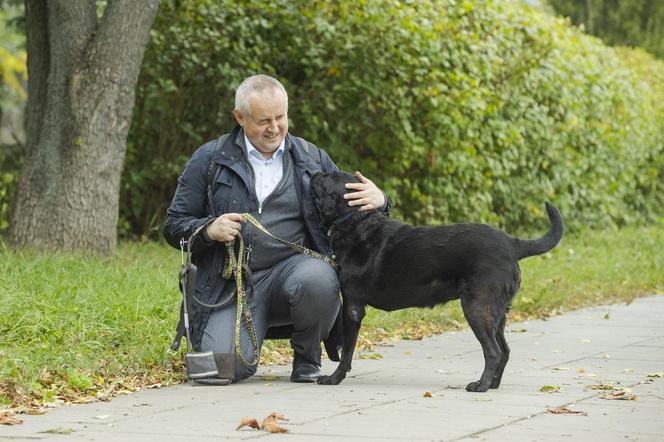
9, 0, 159, 253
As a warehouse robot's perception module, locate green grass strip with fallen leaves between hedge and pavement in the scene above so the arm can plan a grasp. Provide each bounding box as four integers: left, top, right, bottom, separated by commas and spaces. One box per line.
0, 224, 664, 409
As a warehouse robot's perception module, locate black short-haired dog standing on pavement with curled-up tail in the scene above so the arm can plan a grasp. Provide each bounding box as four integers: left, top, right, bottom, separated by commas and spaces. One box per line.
311, 172, 563, 391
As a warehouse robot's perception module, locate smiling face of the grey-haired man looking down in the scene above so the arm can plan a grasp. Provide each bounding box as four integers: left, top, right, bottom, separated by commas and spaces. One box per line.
234, 89, 288, 158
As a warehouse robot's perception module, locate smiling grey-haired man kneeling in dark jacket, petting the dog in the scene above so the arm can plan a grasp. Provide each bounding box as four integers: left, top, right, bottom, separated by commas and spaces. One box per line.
164, 75, 390, 382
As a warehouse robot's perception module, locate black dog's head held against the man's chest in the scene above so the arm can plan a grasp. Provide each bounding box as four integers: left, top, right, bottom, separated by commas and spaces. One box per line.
311, 172, 359, 229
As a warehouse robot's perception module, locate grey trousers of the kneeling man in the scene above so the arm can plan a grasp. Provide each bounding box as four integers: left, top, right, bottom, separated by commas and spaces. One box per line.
201, 254, 341, 382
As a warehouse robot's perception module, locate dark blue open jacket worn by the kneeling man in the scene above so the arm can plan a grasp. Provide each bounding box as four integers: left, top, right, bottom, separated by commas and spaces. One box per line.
164, 126, 390, 349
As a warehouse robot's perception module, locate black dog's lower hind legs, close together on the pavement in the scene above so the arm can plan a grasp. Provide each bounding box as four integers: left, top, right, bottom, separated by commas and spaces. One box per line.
461, 292, 504, 392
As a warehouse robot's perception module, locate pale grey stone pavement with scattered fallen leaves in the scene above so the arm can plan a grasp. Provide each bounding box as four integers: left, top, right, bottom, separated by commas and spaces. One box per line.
0, 296, 664, 441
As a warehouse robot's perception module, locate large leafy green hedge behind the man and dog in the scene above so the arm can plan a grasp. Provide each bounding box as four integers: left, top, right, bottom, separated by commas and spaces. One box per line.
122, 0, 664, 238
